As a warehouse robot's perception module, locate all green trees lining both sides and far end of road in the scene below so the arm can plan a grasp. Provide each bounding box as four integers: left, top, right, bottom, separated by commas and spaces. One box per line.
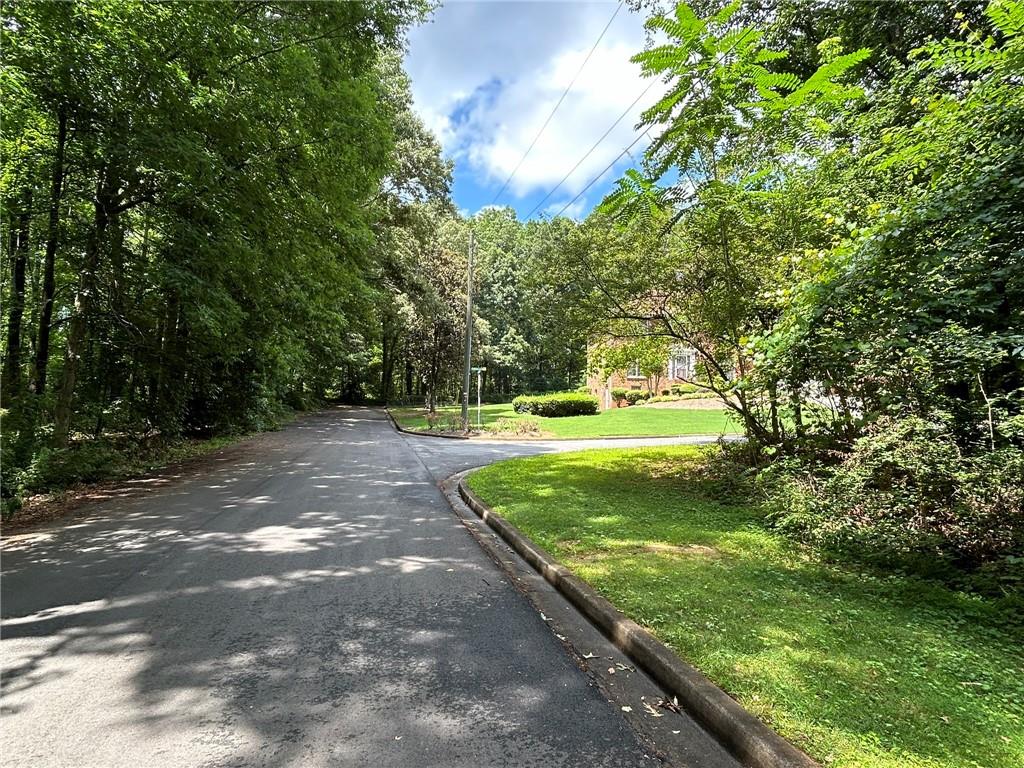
0, 0, 1024, 578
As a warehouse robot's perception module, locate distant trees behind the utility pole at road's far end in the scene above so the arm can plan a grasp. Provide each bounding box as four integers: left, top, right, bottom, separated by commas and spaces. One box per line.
365, 208, 586, 410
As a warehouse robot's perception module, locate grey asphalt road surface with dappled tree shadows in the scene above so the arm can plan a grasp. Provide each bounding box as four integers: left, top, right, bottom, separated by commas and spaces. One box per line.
0, 410, 733, 768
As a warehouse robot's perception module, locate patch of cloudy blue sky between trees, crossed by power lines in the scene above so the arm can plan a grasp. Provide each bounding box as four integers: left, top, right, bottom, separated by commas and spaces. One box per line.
406, 0, 659, 218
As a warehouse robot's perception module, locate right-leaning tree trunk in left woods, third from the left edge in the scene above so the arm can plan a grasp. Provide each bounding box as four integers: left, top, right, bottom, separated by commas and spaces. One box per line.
53, 172, 111, 447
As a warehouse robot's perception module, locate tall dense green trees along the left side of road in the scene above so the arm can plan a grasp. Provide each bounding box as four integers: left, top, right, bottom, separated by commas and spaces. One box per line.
0, 0, 450, 512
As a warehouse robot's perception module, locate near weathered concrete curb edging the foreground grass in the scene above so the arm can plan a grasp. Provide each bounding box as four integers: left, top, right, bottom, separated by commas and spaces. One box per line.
459, 475, 820, 768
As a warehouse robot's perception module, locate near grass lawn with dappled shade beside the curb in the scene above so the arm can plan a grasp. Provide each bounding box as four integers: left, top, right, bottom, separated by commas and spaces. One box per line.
469, 446, 1024, 768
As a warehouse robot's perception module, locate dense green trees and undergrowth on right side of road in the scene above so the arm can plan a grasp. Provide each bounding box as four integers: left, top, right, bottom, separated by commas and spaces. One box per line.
540, 0, 1024, 586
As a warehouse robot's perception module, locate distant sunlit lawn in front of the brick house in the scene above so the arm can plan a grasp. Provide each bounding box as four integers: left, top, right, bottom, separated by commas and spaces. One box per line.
391, 402, 740, 437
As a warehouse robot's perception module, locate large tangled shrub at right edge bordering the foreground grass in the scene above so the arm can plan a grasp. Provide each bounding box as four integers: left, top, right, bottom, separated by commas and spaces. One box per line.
759, 417, 1024, 582
